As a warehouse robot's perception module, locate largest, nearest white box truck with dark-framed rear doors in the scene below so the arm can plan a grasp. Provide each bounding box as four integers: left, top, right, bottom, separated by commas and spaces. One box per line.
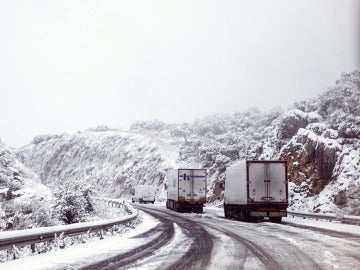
224, 160, 288, 223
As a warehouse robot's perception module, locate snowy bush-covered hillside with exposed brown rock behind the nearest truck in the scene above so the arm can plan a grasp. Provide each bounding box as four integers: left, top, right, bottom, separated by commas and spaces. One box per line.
172, 71, 360, 215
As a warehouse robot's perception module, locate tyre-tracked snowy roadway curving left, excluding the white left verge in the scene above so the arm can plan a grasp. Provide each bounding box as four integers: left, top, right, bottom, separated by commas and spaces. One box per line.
84, 204, 360, 270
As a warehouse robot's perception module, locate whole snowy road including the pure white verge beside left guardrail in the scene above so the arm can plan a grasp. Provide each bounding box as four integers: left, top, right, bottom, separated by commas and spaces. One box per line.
0, 203, 360, 270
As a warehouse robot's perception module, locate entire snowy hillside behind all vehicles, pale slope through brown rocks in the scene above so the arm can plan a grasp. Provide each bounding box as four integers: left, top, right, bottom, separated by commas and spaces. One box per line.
17, 72, 360, 215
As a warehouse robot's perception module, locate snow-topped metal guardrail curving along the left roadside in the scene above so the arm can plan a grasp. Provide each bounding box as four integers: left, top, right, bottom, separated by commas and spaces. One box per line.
0, 199, 138, 250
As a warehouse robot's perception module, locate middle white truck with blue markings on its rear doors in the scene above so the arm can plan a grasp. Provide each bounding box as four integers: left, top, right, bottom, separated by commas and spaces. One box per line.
166, 169, 206, 213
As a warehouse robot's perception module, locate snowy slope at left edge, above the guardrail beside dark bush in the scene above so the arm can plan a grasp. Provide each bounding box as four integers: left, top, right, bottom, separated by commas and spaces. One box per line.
0, 141, 53, 231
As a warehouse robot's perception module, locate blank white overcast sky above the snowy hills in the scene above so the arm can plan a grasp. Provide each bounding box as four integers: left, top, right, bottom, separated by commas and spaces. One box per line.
0, 0, 360, 146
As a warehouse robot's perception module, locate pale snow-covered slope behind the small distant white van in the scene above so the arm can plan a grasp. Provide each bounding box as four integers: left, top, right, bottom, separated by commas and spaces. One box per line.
18, 127, 194, 197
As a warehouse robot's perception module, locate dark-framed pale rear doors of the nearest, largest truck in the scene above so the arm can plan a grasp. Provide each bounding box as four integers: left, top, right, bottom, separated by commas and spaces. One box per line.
247, 161, 287, 203
